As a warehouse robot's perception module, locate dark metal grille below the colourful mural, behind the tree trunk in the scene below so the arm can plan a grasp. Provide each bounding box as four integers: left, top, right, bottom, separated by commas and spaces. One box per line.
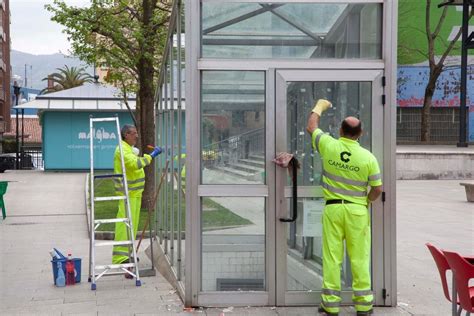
397, 108, 459, 144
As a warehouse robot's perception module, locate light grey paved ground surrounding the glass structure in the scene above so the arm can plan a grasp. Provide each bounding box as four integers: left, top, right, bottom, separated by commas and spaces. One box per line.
0, 171, 474, 316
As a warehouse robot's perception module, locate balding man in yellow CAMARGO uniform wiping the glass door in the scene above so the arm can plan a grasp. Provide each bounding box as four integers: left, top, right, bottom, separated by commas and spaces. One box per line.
306, 100, 382, 315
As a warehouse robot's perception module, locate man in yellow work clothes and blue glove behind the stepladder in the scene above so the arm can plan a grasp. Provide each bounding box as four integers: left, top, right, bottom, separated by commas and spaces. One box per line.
112, 125, 161, 266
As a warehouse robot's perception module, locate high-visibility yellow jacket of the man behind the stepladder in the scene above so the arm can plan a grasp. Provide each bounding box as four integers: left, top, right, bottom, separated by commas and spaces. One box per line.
114, 140, 152, 197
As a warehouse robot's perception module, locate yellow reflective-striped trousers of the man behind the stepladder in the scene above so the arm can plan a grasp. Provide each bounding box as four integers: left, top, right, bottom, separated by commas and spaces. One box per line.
112, 196, 142, 264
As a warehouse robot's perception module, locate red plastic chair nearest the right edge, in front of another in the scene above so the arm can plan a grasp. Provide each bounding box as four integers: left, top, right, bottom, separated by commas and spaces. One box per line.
443, 250, 474, 314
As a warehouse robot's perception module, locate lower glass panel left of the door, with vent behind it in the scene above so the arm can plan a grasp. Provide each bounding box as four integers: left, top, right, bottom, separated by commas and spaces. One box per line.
201, 197, 265, 291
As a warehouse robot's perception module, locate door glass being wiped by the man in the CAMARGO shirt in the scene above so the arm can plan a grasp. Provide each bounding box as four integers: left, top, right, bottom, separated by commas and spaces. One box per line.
286, 81, 372, 291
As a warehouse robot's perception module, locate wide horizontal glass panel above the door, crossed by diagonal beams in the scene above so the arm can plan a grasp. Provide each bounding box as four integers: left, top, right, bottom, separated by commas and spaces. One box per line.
202, 1, 382, 59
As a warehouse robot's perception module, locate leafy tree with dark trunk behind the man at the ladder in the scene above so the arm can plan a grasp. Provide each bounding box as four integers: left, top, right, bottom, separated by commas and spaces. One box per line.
46, 0, 173, 208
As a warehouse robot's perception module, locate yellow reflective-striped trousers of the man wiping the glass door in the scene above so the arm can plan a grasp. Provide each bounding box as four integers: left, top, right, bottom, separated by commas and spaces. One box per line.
321, 204, 374, 313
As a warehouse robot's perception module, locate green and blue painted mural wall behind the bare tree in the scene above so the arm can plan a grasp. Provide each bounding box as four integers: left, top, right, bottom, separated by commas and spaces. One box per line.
397, 0, 474, 142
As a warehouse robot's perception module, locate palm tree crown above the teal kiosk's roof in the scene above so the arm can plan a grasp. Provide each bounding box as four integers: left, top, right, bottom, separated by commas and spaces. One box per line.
41, 65, 93, 94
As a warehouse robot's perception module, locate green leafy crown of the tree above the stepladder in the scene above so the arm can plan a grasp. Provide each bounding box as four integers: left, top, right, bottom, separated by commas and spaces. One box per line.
45, 0, 171, 100
